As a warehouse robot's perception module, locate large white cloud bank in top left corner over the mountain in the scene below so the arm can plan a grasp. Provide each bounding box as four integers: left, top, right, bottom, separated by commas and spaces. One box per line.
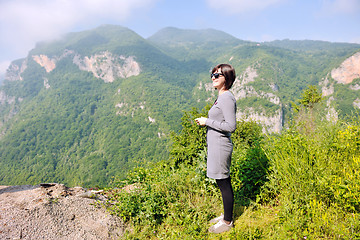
0, 0, 159, 60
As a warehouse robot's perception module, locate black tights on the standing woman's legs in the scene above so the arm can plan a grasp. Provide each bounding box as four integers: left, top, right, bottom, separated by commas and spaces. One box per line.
216, 177, 234, 222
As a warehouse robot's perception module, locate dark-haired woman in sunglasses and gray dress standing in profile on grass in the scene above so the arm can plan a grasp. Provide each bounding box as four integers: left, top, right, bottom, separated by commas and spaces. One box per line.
195, 64, 236, 233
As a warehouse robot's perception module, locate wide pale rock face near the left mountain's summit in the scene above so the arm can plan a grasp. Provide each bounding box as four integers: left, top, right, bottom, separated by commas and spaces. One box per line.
73, 51, 141, 82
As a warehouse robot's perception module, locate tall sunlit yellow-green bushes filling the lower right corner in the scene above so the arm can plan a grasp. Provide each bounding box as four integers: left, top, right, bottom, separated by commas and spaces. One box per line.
261, 108, 360, 239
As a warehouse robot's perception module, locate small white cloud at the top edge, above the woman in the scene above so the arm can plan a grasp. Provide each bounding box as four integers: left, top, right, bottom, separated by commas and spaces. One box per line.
206, 0, 284, 14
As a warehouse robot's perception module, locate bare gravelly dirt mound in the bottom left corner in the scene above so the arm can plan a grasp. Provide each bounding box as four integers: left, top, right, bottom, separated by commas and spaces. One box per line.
0, 183, 124, 240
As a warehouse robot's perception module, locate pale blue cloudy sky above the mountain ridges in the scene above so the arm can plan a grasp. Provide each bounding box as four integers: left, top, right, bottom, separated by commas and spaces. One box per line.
0, 0, 360, 76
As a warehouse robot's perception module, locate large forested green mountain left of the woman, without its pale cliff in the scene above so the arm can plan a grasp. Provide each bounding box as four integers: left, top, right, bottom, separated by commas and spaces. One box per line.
0, 26, 211, 185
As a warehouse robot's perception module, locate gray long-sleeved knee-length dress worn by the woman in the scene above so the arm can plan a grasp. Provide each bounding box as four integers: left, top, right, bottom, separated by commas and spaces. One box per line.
205, 91, 236, 179
